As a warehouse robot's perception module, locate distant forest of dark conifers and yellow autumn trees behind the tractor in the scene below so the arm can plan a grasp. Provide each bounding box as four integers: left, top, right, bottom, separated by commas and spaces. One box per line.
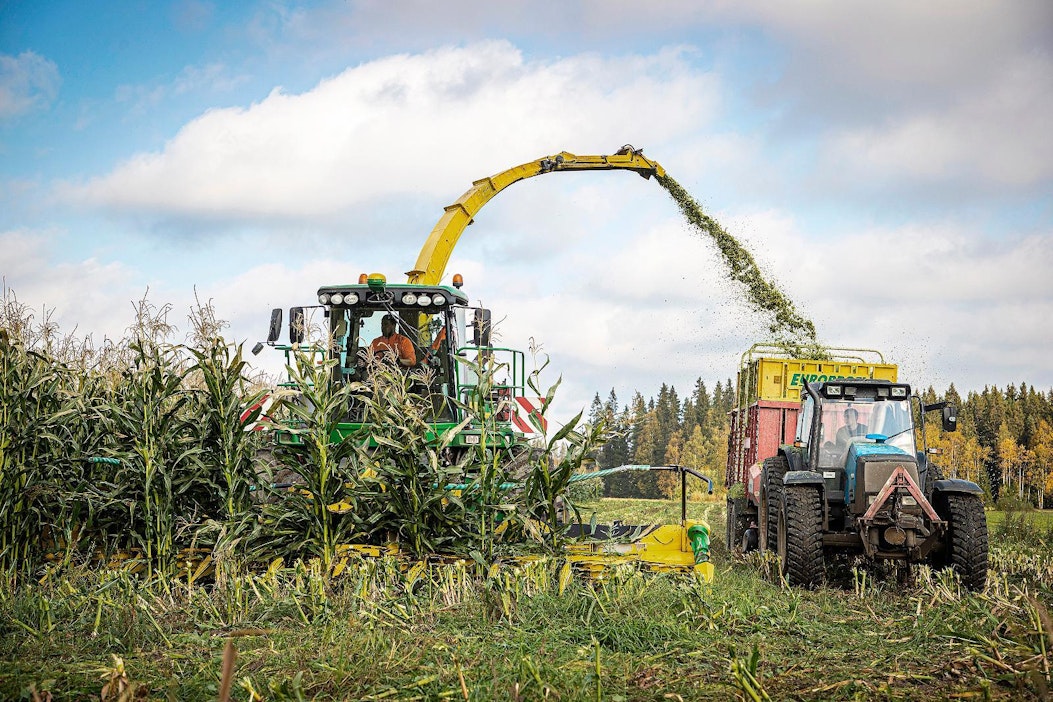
589, 378, 1053, 508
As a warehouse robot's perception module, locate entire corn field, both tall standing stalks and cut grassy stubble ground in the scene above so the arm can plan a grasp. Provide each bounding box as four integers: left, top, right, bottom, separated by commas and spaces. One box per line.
0, 293, 1053, 702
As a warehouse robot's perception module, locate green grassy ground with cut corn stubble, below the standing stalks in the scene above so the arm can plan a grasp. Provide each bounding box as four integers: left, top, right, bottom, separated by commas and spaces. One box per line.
0, 500, 1053, 701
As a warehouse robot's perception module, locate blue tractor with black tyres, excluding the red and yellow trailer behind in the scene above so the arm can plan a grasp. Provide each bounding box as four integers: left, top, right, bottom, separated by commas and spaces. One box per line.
757, 379, 988, 590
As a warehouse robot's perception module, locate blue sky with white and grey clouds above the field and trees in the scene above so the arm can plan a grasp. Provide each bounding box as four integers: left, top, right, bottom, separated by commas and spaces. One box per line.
0, 0, 1053, 413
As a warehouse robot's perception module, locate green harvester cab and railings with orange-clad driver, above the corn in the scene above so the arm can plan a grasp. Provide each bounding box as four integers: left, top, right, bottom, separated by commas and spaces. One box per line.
254, 274, 531, 455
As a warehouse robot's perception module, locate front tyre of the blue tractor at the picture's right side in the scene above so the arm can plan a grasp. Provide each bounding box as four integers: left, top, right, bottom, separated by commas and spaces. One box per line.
935, 494, 988, 591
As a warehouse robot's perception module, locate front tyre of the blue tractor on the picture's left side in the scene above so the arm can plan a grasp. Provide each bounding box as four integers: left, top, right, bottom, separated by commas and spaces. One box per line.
776, 485, 823, 587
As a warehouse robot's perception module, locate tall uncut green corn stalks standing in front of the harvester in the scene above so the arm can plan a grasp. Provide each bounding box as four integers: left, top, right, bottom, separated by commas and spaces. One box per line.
0, 293, 603, 578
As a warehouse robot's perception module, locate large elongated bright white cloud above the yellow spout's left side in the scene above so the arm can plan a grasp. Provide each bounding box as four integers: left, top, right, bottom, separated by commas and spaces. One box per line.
55, 42, 719, 225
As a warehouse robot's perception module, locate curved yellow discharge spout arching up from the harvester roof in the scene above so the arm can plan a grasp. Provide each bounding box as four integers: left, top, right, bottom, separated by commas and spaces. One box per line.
406, 144, 665, 285
